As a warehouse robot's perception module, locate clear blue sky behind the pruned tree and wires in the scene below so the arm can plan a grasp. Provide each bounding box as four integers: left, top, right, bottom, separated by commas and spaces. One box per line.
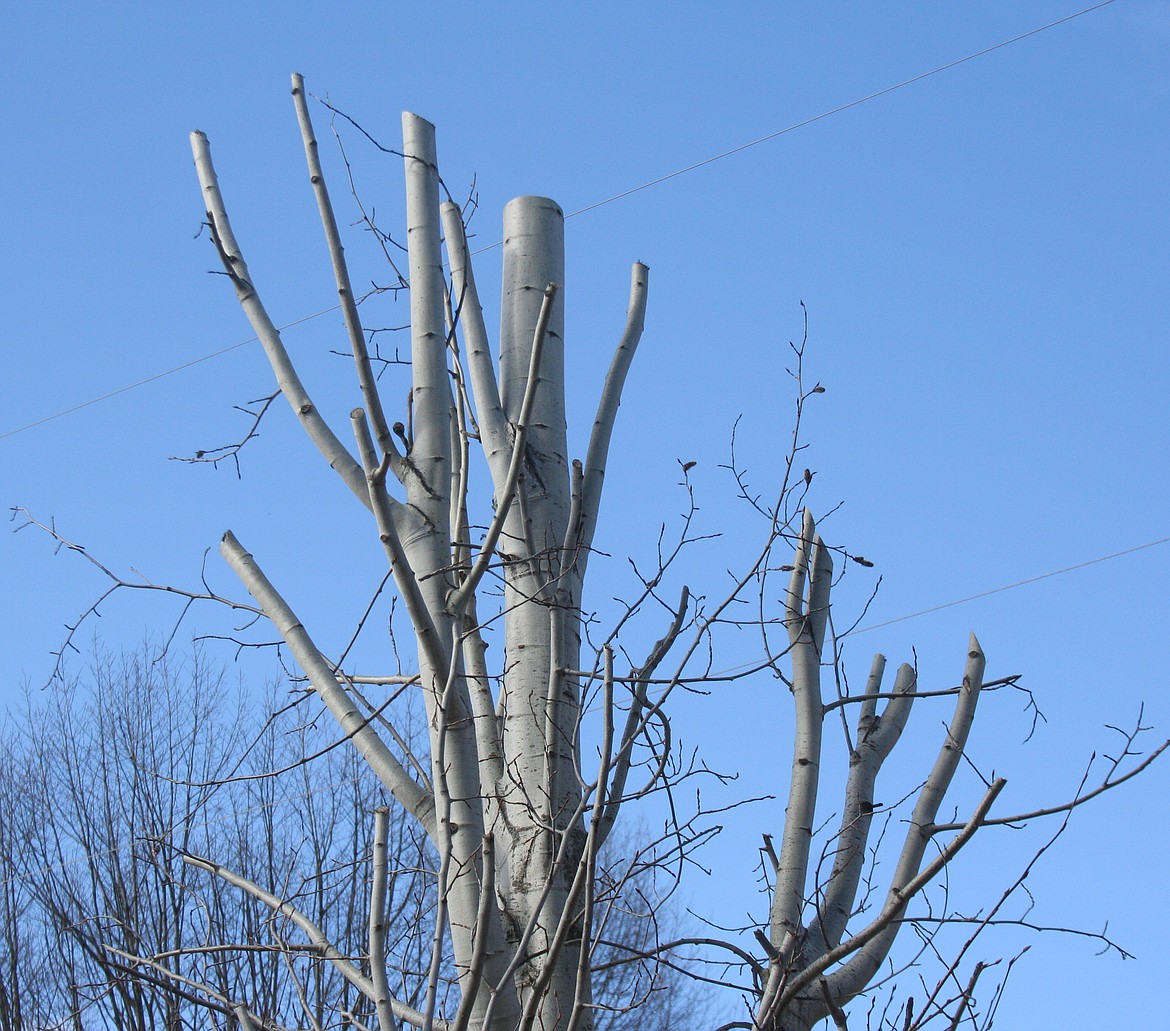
0, 0, 1170, 1029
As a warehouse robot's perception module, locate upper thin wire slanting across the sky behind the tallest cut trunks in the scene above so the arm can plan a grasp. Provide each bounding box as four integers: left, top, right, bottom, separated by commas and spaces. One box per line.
0, 0, 1116, 440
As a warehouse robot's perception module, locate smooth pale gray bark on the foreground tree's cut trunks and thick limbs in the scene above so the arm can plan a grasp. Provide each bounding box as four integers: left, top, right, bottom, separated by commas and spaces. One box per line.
195, 106, 996, 1031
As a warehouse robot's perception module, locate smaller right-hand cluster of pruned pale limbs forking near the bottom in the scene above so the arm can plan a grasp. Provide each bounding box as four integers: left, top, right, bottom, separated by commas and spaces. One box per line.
755, 510, 1003, 1031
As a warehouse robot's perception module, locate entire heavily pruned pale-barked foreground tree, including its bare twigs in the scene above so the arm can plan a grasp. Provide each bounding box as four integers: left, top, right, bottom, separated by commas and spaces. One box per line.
13, 76, 1165, 1031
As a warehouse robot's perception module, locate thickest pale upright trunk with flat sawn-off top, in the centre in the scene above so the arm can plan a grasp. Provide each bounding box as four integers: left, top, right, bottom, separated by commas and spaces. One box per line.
496, 197, 587, 1029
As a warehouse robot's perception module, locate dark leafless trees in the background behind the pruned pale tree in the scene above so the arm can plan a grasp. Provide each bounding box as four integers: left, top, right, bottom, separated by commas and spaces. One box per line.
0, 647, 697, 1031
